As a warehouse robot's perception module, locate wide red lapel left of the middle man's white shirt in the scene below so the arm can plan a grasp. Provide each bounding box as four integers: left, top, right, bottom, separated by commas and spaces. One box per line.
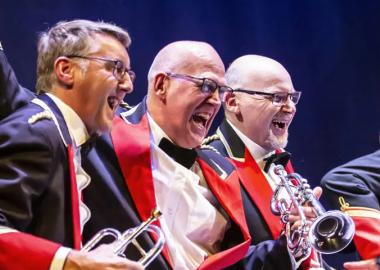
111, 115, 171, 265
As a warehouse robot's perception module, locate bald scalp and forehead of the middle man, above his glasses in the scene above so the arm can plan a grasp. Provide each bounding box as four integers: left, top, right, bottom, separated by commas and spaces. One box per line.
148, 41, 225, 89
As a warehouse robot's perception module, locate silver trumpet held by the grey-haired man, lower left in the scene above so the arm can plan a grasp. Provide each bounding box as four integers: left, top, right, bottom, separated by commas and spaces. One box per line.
81, 209, 165, 267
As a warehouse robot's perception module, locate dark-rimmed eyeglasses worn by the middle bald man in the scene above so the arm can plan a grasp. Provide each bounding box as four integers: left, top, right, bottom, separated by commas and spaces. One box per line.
166, 72, 233, 94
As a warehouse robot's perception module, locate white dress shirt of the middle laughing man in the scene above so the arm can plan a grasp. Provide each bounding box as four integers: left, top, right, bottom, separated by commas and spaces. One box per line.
148, 115, 228, 269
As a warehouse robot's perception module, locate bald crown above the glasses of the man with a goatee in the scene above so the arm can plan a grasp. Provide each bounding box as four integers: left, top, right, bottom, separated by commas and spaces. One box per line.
226, 54, 291, 90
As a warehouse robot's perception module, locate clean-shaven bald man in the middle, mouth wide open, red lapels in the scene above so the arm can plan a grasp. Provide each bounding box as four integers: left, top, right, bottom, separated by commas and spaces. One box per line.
84, 41, 256, 269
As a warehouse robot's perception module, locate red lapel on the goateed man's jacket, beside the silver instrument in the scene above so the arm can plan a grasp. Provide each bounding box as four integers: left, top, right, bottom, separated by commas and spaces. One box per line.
233, 149, 282, 239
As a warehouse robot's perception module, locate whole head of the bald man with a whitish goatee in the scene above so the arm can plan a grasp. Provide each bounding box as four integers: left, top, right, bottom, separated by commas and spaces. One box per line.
223, 55, 296, 151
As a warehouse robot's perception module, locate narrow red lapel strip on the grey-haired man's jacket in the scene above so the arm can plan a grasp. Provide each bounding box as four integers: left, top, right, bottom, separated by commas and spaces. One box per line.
67, 144, 82, 250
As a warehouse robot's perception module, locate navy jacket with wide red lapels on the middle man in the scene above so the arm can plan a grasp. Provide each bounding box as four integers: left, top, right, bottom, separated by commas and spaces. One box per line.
83, 100, 254, 269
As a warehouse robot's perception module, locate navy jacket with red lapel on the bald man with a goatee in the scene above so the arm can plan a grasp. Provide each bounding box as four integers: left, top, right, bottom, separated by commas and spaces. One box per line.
206, 119, 308, 269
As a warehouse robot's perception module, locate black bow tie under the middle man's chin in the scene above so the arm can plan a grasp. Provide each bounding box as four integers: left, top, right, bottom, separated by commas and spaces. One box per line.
158, 138, 197, 169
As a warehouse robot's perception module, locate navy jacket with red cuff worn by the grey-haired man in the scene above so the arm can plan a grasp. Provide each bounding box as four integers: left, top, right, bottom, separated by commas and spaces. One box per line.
0, 96, 80, 269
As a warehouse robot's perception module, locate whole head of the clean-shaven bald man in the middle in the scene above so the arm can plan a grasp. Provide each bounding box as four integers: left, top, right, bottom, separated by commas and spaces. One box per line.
147, 41, 226, 148
